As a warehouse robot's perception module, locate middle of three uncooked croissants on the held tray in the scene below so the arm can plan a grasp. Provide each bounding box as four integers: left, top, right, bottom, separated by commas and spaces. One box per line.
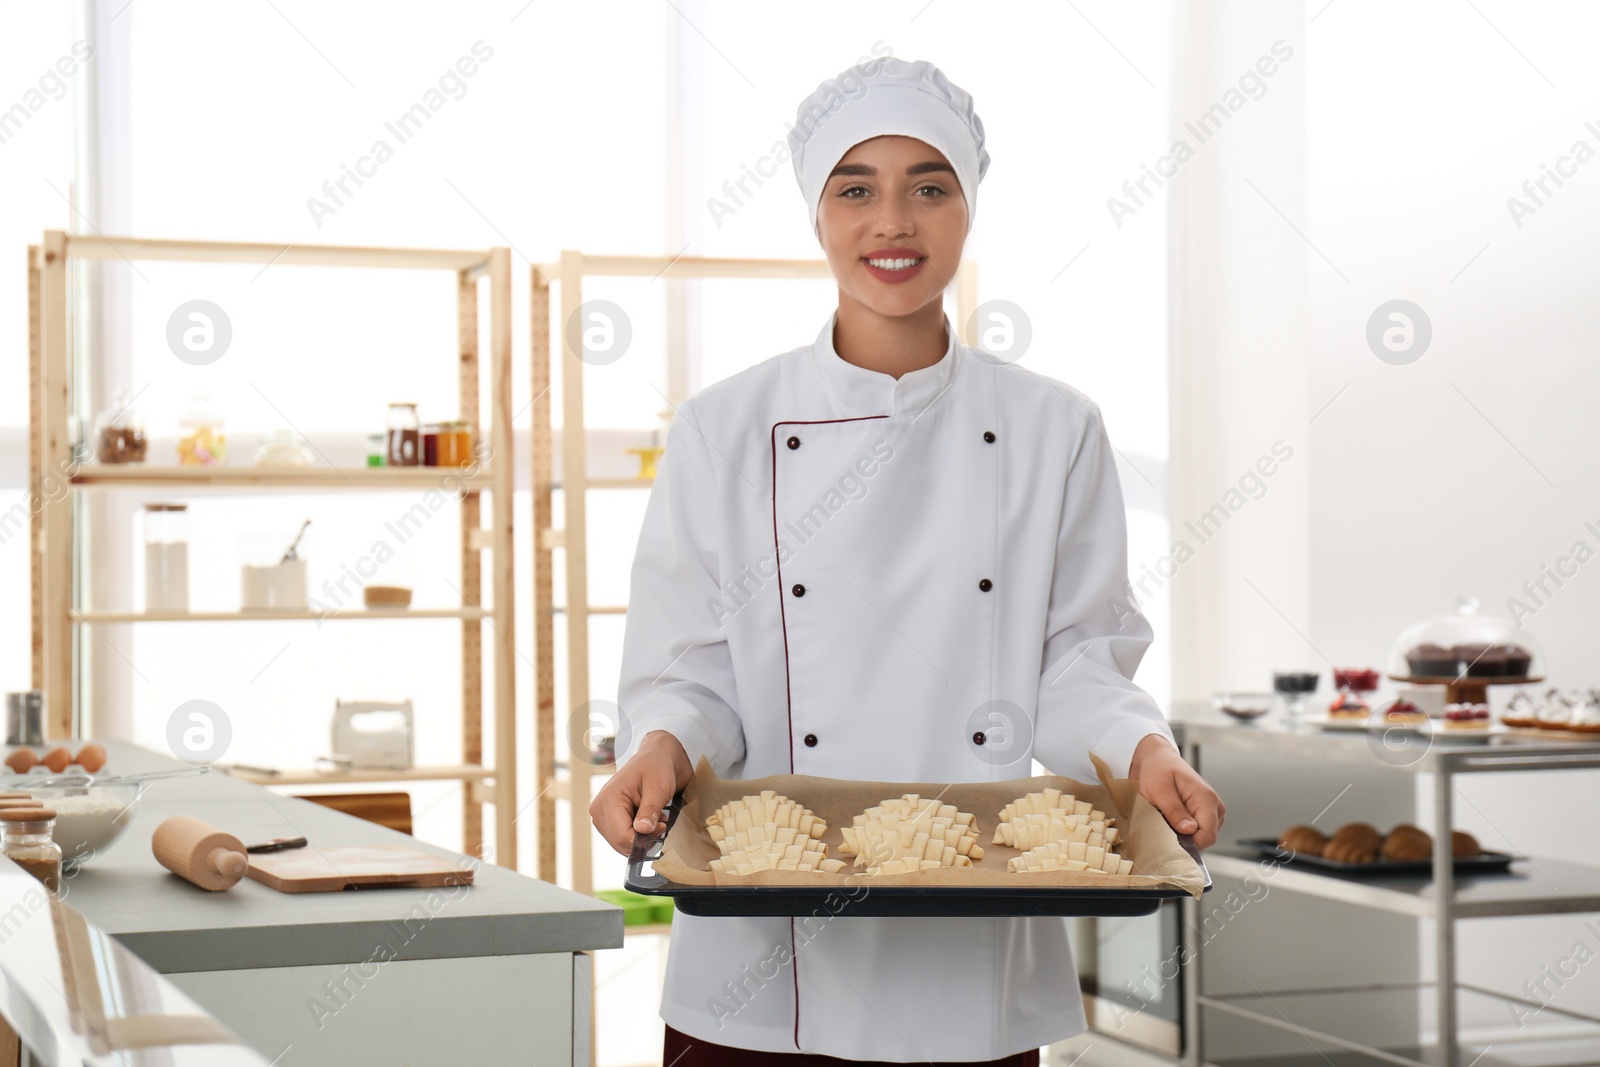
838, 793, 984, 875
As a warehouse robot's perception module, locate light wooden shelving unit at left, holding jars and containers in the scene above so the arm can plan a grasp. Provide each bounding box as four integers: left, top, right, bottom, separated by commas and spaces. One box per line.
27, 230, 518, 869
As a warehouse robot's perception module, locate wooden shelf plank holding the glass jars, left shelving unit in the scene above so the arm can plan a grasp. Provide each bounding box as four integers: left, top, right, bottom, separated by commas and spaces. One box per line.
72, 464, 490, 491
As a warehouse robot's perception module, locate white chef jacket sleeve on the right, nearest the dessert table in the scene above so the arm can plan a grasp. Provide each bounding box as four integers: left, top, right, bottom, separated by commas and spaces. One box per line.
1034, 396, 1173, 782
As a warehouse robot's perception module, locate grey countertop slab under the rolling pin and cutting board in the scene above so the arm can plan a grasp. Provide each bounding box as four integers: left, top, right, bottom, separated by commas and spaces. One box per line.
29, 741, 622, 973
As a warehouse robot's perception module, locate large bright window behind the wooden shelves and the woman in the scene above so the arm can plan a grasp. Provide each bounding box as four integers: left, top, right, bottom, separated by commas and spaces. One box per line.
0, 2, 1168, 876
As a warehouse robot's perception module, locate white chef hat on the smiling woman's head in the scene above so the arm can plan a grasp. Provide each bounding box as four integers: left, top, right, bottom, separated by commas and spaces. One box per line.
789, 56, 989, 237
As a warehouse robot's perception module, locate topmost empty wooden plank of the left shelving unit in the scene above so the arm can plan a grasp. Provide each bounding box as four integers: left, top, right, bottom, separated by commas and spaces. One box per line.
67, 234, 488, 270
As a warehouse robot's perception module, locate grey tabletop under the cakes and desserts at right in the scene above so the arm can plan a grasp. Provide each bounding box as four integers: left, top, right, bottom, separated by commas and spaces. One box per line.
1171, 699, 1600, 773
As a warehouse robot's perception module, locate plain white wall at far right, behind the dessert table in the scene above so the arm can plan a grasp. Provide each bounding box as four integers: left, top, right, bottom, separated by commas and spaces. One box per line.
1306, 0, 1600, 1022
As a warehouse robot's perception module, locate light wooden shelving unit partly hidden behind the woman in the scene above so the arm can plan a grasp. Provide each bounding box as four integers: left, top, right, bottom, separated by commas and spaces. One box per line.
531, 251, 978, 893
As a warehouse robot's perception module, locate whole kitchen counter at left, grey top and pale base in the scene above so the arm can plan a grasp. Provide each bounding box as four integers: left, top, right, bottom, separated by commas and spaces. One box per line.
31, 741, 622, 1067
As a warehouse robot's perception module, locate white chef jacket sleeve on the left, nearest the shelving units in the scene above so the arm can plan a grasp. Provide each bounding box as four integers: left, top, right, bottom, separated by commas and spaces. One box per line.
618, 402, 744, 777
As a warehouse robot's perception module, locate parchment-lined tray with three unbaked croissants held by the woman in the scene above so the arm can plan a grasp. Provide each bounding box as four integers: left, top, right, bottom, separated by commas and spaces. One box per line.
624, 758, 1211, 915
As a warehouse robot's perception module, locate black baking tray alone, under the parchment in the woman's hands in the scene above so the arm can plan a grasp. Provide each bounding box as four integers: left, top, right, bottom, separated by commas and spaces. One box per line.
622, 793, 1211, 917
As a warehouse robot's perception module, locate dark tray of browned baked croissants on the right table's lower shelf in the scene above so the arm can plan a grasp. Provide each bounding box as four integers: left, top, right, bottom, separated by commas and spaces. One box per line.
1240, 822, 1515, 875
